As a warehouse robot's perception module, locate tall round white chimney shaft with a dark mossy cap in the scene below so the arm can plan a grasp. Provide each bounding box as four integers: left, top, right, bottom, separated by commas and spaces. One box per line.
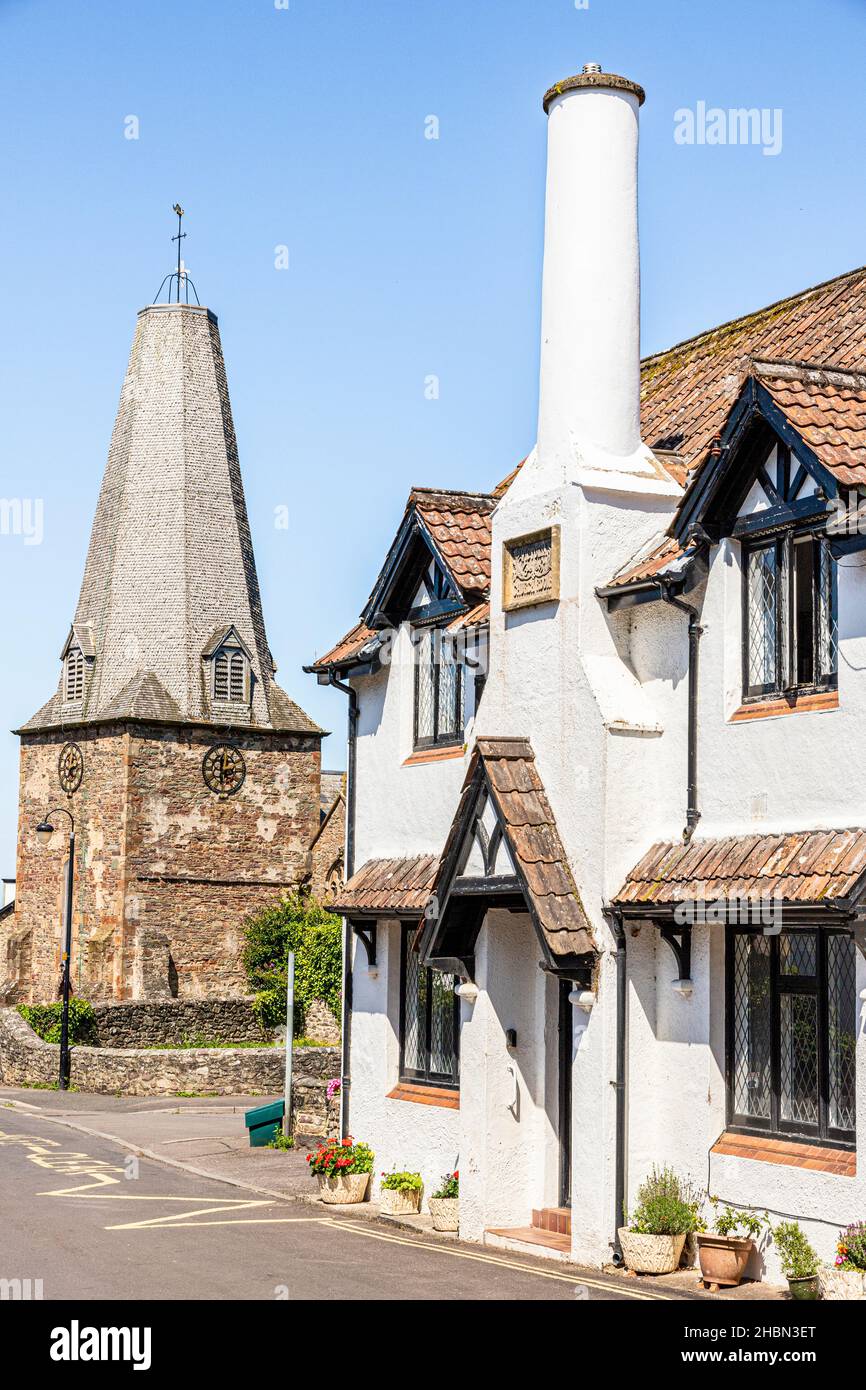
538, 64, 646, 478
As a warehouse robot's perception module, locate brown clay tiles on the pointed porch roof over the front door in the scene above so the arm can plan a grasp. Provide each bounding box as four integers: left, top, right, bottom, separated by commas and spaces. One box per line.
431, 738, 595, 956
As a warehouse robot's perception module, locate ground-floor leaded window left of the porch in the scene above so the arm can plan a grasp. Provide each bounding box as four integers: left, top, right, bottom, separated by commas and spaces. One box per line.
400, 923, 459, 1086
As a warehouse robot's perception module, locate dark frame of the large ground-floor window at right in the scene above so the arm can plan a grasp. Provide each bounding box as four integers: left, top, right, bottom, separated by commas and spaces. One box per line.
724, 926, 856, 1150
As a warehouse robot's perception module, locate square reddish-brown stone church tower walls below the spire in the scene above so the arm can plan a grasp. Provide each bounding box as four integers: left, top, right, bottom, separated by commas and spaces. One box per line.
11, 724, 320, 1002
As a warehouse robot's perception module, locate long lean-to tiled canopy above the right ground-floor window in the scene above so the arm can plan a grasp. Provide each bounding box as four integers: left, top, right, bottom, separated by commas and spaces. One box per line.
612, 828, 866, 979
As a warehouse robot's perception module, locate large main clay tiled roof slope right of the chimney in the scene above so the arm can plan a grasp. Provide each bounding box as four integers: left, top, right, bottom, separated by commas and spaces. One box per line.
641, 268, 866, 478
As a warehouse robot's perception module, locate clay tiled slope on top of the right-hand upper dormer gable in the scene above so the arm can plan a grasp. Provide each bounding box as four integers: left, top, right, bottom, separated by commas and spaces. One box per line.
762, 371, 866, 487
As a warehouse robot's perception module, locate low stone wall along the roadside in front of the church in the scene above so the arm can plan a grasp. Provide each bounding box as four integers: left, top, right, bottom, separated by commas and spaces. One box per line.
0, 1008, 341, 1134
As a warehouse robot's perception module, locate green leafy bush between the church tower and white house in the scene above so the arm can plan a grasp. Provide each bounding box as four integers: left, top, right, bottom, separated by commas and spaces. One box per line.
243, 892, 342, 1037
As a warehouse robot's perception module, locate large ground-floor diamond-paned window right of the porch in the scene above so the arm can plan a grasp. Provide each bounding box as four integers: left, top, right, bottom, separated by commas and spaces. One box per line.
727, 929, 856, 1144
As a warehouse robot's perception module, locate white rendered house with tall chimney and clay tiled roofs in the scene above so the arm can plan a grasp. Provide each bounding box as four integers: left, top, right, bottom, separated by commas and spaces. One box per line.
310, 65, 866, 1275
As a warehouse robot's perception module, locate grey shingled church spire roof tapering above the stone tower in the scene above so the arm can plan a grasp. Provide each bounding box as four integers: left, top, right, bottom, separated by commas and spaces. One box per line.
24, 304, 321, 734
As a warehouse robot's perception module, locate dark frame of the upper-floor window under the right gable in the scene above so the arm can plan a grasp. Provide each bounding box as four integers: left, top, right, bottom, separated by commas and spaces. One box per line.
741, 525, 838, 703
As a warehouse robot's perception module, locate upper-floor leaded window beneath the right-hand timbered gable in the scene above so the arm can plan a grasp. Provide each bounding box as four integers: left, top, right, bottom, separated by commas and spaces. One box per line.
744, 531, 838, 699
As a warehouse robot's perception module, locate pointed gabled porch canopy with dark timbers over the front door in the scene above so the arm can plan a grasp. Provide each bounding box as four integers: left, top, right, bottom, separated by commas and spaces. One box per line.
417, 738, 596, 984
